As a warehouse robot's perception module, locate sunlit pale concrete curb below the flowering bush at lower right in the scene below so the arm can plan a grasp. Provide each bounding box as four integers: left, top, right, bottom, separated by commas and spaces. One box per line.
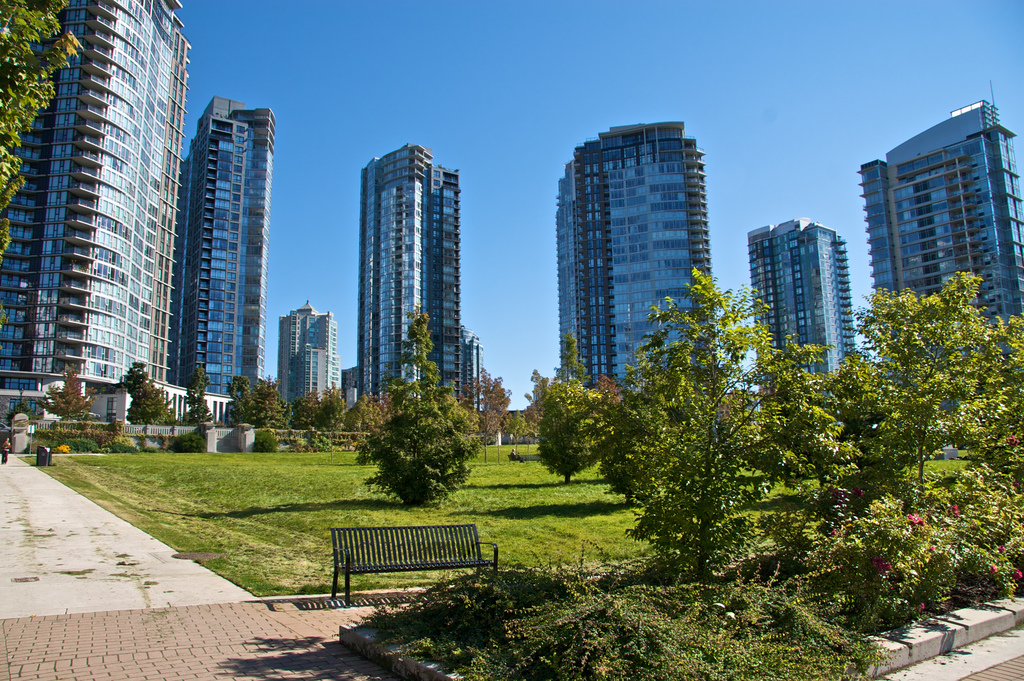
868, 598, 1024, 677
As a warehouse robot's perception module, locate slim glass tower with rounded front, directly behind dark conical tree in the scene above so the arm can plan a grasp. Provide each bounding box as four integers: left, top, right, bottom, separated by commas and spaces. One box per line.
356, 144, 461, 394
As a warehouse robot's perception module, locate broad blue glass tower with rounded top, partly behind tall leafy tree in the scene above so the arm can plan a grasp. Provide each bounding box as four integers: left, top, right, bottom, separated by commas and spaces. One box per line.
555, 123, 711, 379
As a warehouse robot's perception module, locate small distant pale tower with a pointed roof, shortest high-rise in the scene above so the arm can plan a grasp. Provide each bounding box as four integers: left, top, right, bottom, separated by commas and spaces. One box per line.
278, 300, 341, 401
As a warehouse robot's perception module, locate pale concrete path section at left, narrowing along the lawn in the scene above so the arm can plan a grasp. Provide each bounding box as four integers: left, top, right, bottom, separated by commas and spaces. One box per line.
0, 456, 253, 619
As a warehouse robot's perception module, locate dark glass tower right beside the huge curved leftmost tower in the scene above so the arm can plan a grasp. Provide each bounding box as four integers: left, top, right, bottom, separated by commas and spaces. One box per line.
172, 97, 274, 394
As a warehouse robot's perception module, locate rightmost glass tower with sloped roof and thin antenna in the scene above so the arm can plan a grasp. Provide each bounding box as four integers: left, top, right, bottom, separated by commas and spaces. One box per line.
860, 101, 1024, 317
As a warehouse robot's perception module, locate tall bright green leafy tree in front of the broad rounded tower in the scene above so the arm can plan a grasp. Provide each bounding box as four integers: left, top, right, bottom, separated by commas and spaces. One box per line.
602, 270, 836, 577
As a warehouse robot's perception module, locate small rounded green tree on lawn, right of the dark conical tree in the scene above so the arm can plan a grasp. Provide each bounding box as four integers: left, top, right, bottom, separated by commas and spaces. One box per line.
537, 379, 599, 484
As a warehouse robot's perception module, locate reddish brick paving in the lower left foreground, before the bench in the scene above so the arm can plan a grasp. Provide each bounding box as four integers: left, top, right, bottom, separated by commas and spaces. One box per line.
0, 599, 396, 681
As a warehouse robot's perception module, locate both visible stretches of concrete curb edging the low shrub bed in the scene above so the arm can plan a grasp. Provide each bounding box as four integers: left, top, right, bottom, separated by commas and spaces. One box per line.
339, 598, 1024, 681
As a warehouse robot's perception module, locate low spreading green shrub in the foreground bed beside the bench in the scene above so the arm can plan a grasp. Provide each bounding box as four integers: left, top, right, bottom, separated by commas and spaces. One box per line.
368, 567, 874, 681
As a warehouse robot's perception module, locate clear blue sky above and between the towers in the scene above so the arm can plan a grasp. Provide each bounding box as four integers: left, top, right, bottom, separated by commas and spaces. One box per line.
178, 0, 1024, 408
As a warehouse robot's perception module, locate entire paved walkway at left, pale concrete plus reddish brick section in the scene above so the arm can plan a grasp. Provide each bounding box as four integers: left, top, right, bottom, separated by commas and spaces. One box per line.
0, 457, 396, 681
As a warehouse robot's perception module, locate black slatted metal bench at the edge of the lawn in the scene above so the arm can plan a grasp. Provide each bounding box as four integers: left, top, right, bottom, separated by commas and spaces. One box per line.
331, 524, 498, 605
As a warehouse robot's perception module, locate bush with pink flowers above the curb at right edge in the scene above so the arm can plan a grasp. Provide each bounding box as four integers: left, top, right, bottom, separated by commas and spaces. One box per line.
807, 466, 1024, 630
